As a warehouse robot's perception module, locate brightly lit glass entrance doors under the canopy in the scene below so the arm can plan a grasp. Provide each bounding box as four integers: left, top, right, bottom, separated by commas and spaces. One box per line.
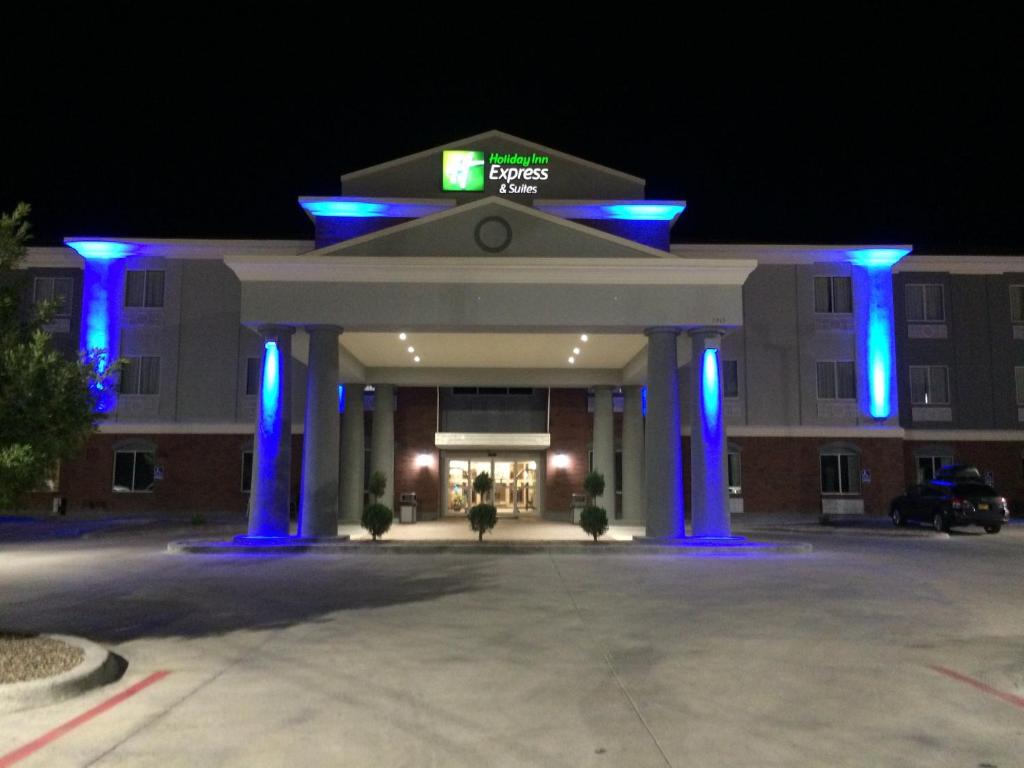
446, 455, 538, 516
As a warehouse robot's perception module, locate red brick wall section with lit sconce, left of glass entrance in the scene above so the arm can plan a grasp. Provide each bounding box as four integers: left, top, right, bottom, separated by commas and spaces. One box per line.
394, 387, 441, 519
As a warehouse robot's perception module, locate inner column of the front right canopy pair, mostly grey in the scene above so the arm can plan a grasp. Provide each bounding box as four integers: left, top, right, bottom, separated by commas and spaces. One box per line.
644, 328, 686, 539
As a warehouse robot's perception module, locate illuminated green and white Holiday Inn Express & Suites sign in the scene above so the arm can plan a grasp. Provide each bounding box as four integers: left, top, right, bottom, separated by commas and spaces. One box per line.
441, 150, 551, 195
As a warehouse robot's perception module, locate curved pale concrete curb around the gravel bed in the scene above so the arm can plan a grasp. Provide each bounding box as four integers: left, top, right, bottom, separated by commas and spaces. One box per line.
0, 635, 128, 715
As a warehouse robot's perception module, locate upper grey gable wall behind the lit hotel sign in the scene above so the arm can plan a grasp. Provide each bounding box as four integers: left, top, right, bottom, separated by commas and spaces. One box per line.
341, 130, 645, 202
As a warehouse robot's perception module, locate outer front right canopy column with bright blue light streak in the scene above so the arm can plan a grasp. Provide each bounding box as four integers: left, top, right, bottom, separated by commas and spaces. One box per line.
690, 328, 731, 537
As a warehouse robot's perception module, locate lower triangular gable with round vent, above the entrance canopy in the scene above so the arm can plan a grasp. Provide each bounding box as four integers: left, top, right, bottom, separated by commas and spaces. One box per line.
313, 198, 672, 259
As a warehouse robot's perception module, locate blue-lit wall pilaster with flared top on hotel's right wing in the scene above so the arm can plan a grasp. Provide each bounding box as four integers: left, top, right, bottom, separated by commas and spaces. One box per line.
848, 248, 909, 419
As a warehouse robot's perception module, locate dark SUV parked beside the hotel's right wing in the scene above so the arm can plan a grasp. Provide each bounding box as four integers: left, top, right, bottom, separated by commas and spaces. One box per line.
889, 465, 1010, 534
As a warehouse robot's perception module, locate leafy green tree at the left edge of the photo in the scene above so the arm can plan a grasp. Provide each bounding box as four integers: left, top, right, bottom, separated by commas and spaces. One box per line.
0, 203, 110, 509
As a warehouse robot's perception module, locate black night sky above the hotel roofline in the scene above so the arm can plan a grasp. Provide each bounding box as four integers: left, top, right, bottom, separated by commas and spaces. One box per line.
0, 6, 1024, 253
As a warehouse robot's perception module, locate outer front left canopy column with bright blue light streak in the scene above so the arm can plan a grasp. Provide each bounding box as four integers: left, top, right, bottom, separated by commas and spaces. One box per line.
249, 326, 294, 537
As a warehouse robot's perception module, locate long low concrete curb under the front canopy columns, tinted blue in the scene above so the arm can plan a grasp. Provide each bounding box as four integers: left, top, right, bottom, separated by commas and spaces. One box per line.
167, 540, 813, 557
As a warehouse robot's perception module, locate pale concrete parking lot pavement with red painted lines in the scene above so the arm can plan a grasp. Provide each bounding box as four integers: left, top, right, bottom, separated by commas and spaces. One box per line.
0, 526, 1024, 767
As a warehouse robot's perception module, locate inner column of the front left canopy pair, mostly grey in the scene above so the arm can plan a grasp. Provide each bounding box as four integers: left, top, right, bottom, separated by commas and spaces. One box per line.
299, 326, 341, 537
